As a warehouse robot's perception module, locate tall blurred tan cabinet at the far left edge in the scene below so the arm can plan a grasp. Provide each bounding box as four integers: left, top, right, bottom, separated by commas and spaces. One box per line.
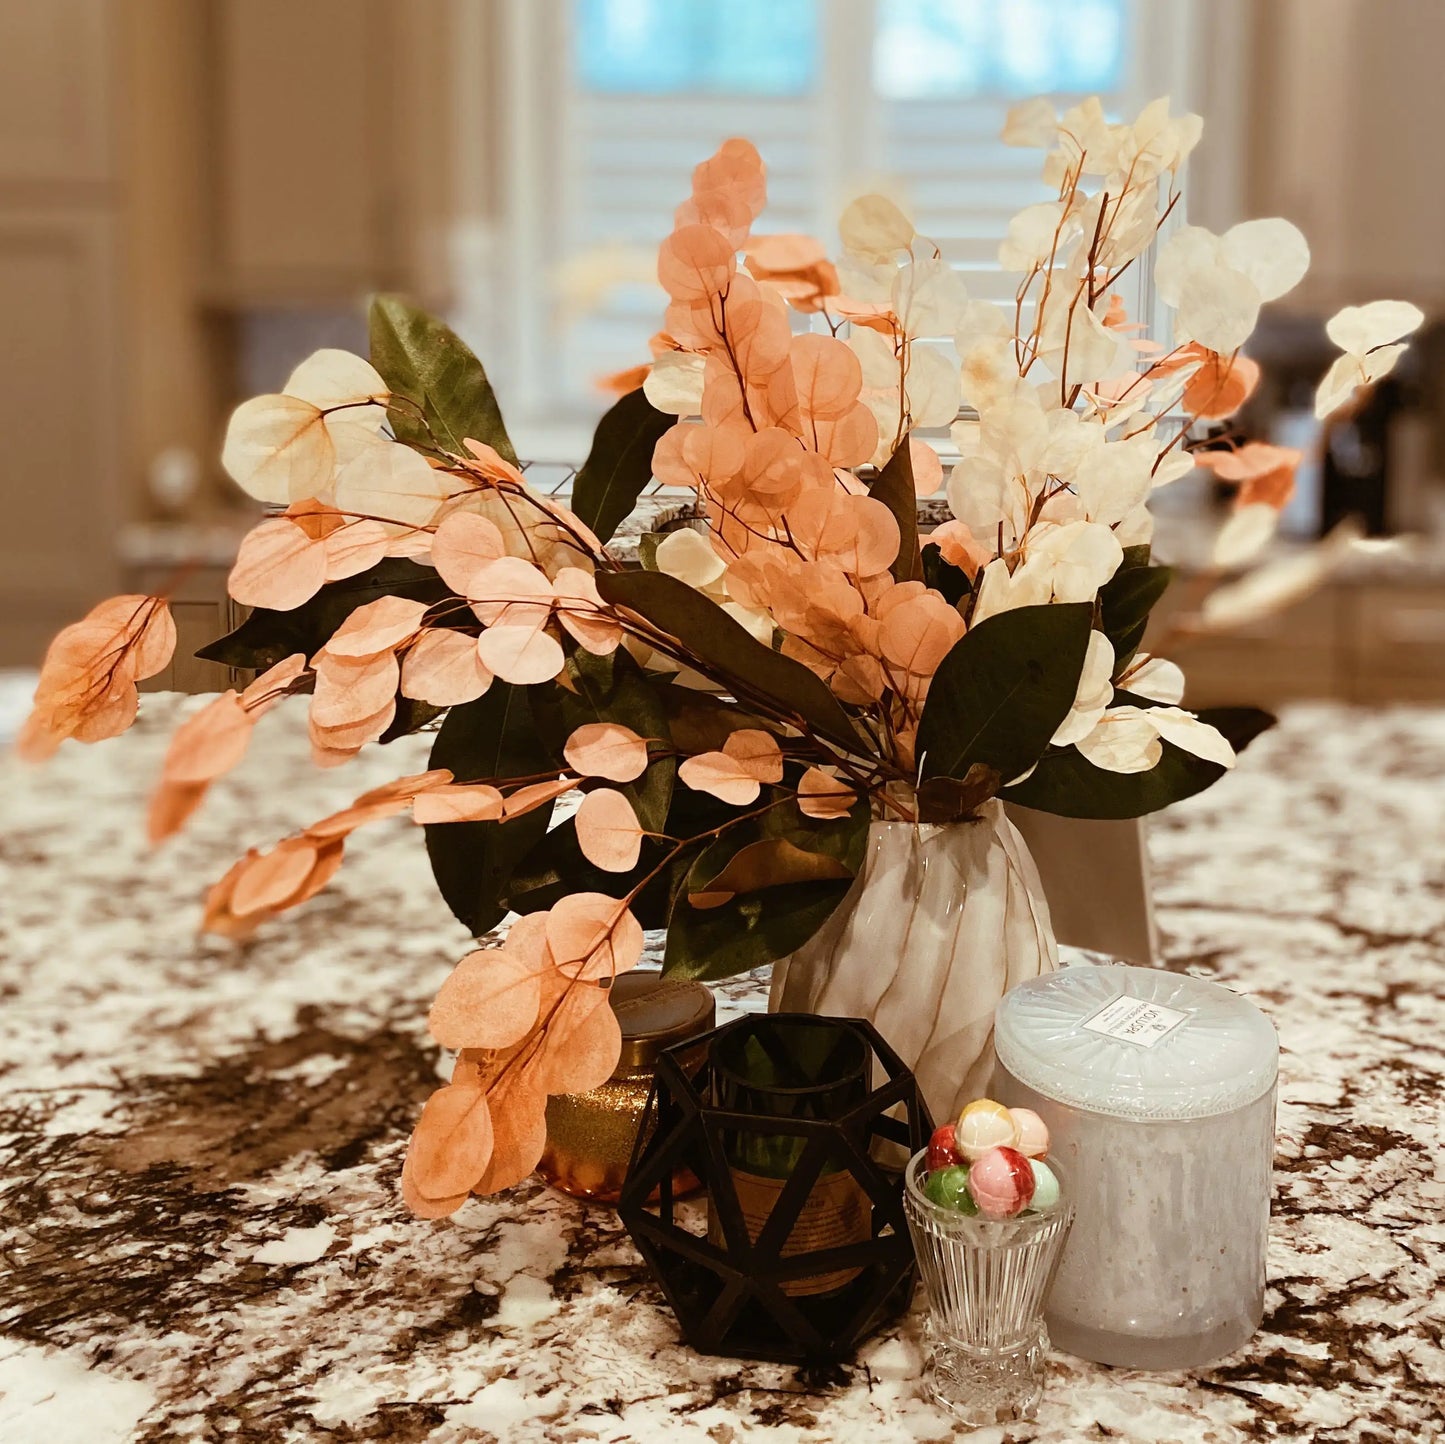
0, 0, 121, 665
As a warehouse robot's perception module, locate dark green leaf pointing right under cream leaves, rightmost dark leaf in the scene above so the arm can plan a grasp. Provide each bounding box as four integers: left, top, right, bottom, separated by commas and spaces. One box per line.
1003, 705, 1274, 818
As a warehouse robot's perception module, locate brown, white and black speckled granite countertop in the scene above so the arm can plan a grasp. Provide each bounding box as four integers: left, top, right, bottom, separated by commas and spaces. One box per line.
0, 695, 1445, 1444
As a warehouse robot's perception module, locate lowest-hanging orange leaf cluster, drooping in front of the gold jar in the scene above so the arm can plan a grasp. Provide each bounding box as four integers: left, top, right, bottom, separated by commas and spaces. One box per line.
402, 893, 643, 1219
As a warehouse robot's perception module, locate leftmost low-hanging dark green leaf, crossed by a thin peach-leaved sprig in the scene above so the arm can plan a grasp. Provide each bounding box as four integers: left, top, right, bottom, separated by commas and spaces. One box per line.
426, 681, 552, 937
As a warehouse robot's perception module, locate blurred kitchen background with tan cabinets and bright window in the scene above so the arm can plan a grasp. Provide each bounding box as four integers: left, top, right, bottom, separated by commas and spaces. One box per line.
0, 0, 1445, 733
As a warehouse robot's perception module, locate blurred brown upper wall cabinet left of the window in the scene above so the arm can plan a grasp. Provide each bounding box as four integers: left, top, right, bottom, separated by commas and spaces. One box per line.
204, 0, 452, 309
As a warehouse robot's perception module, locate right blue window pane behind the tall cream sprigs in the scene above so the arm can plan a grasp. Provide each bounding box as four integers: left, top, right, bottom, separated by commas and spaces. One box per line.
873, 0, 1130, 100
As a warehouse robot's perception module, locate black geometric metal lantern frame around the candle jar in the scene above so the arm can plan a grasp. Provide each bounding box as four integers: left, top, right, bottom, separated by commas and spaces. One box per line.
618, 1013, 932, 1365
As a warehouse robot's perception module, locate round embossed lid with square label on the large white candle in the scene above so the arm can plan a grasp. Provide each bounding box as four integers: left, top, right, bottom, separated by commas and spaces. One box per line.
994, 966, 1279, 1120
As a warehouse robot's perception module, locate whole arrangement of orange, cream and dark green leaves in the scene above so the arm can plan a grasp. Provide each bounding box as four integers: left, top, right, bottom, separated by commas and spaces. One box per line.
20, 100, 1420, 1217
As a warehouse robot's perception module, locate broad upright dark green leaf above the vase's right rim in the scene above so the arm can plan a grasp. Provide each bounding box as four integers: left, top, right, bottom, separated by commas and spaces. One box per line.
916, 601, 1094, 797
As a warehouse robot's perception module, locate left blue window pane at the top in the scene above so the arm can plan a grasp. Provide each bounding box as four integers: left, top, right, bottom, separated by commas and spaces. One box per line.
574, 0, 818, 95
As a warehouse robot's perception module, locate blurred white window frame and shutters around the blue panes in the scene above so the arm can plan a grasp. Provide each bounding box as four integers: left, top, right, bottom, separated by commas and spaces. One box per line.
485, 0, 1192, 452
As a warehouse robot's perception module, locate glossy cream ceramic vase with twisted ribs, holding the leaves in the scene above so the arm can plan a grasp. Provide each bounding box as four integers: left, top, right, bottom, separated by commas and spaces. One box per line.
769, 801, 1059, 1120
